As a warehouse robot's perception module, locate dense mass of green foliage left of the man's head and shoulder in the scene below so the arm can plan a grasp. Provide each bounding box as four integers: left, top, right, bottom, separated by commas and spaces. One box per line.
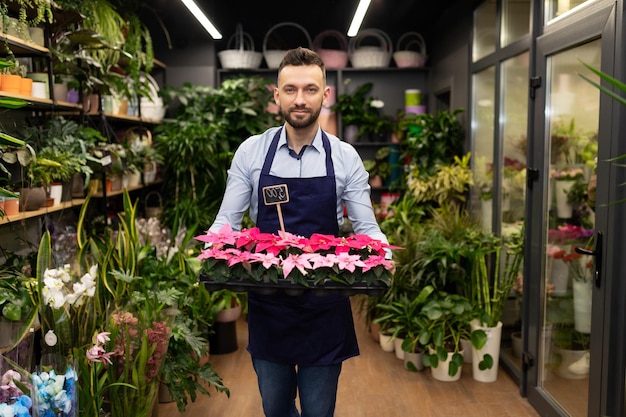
155, 77, 276, 227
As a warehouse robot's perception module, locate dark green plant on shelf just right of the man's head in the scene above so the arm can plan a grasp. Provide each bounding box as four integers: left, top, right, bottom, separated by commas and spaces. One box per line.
331, 79, 393, 143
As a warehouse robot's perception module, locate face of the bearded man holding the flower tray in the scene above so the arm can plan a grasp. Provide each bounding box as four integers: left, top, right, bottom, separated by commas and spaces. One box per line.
274, 65, 330, 128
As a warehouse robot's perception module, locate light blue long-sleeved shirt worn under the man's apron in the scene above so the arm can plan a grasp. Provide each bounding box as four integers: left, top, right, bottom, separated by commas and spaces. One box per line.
209, 122, 387, 242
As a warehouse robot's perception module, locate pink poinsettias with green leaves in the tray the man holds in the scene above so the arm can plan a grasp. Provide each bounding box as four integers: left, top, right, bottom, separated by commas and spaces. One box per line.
196, 225, 396, 287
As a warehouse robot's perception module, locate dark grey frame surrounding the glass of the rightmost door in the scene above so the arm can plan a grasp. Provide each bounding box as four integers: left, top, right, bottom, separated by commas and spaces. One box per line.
522, 0, 626, 416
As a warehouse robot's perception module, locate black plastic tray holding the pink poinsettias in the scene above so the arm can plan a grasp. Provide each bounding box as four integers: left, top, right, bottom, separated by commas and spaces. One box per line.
200, 274, 389, 297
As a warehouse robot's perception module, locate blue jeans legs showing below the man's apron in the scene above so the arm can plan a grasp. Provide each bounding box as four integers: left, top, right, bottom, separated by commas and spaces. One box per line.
252, 358, 341, 417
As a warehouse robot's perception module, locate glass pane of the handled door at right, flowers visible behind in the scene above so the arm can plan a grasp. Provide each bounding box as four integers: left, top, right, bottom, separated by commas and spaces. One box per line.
539, 40, 601, 417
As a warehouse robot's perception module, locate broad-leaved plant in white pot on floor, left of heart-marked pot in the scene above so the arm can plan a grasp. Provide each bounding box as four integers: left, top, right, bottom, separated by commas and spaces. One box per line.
419, 291, 487, 381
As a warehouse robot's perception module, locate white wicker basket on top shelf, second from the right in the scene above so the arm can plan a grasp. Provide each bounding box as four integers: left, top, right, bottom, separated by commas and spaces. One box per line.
349, 29, 393, 68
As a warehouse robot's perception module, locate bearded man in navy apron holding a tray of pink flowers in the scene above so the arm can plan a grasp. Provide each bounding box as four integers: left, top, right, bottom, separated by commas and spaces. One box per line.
210, 48, 387, 417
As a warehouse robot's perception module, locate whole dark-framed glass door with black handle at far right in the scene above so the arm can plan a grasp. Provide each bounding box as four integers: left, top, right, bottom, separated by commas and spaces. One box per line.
525, 2, 623, 417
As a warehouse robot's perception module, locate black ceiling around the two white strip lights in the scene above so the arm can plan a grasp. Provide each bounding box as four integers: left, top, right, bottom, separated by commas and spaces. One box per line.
142, 0, 463, 51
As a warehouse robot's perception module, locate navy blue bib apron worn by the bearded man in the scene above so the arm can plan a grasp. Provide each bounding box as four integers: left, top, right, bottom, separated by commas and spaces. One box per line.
248, 129, 359, 365
